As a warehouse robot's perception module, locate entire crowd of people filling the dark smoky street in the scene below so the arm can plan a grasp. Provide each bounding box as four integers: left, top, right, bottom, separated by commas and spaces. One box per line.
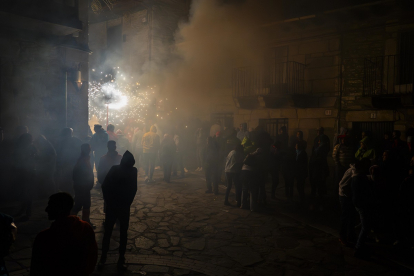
0, 122, 414, 275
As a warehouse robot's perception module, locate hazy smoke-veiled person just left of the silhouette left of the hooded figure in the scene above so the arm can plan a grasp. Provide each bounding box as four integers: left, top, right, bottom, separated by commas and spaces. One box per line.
56, 128, 82, 194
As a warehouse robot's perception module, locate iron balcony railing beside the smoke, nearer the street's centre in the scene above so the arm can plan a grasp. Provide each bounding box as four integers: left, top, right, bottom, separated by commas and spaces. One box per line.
232, 61, 305, 97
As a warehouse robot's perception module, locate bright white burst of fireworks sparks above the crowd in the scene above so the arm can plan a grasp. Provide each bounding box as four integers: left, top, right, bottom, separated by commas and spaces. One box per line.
89, 67, 154, 125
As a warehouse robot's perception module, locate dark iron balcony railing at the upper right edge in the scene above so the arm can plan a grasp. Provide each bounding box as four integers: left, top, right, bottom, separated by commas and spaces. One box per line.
363, 55, 414, 96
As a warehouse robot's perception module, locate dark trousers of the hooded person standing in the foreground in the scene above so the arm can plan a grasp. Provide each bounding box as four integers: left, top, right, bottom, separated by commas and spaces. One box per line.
102, 206, 130, 259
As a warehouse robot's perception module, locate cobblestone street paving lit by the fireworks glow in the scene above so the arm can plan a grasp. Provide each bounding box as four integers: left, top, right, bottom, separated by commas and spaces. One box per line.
1, 171, 408, 275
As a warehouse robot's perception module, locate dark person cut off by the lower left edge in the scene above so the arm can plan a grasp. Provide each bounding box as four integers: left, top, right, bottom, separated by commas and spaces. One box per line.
0, 213, 17, 276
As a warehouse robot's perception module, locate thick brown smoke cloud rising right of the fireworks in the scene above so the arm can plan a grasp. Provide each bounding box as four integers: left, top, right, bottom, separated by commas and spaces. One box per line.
161, 0, 280, 115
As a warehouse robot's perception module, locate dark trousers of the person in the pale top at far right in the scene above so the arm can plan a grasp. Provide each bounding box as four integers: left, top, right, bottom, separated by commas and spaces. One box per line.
339, 196, 356, 242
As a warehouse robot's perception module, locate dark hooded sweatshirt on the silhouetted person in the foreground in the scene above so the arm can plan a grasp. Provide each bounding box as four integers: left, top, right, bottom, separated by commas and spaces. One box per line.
102, 151, 138, 210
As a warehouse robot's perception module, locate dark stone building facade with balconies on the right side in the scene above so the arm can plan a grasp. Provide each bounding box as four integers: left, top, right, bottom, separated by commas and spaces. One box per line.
211, 0, 414, 146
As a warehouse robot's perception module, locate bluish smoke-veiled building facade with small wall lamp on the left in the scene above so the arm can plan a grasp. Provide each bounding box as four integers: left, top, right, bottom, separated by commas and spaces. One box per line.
0, 0, 90, 140
